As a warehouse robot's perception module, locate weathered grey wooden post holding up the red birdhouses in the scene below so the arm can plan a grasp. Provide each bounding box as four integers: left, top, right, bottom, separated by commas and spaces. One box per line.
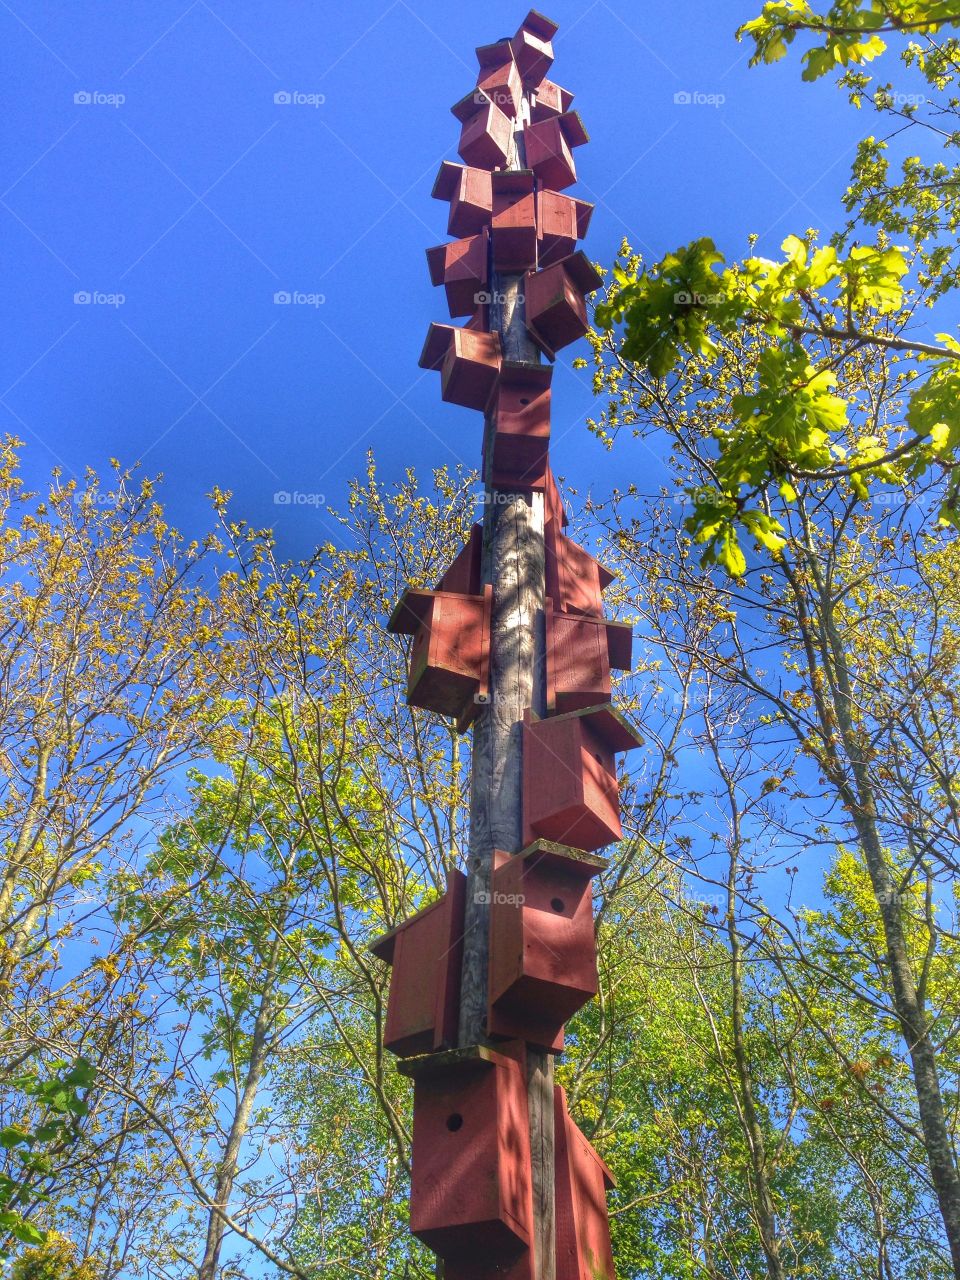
460, 93, 557, 1280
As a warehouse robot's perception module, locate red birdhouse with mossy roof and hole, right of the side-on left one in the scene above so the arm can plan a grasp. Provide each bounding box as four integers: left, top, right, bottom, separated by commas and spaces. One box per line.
486, 840, 605, 1050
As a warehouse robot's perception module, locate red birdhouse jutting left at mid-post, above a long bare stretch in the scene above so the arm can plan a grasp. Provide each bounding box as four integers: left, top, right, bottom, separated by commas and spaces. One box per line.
387, 586, 493, 733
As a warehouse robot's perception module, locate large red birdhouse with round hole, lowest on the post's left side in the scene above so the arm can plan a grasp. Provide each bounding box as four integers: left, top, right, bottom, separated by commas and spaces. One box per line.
398, 1044, 532, 1261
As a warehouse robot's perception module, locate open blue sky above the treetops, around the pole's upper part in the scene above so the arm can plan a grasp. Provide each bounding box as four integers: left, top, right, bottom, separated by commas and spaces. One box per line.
0, 0, 865, 554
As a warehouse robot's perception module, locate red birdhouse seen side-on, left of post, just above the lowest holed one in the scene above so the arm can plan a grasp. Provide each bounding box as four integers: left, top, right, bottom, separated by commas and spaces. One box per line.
370, 870, 467, 1057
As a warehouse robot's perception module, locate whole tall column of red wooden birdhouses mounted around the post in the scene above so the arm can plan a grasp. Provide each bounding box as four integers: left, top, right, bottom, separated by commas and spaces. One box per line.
372, 12, 639, 1280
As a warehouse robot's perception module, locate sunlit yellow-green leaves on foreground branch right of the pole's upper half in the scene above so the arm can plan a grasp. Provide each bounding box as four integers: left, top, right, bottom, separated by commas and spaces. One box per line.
596, 234, 960, 576
